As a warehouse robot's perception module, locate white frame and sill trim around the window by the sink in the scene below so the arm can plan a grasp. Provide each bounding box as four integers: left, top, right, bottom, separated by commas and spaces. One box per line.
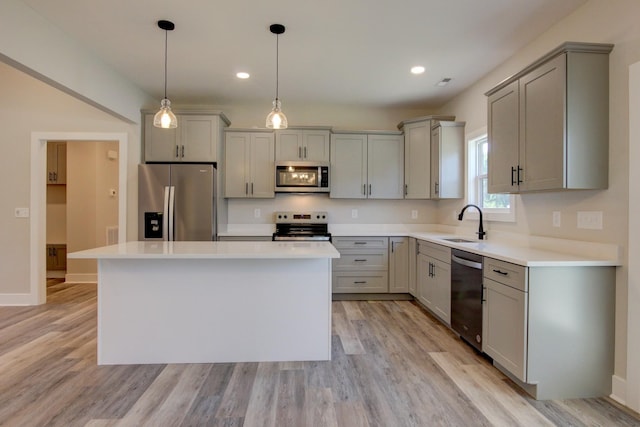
465, 127, 516, 222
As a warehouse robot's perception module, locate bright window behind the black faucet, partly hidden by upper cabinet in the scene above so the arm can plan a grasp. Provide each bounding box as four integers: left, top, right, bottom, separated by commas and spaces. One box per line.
468, 132, 515, 222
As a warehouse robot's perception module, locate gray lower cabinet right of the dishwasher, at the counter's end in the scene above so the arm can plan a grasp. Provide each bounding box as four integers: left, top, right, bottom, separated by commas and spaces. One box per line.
483, 257, 615, 399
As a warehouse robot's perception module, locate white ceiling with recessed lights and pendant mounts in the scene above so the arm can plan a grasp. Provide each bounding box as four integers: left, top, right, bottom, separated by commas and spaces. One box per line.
23, 0, 586, 110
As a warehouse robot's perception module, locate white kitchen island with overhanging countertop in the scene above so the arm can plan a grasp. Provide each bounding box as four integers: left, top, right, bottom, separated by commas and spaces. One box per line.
69, 242, 340, 365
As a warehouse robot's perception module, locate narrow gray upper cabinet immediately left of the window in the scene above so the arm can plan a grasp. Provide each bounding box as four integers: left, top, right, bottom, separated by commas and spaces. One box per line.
431, 120, 465, 199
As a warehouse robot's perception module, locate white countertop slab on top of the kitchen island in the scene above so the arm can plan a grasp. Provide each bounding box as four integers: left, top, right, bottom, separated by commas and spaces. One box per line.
67, 241, 340, 259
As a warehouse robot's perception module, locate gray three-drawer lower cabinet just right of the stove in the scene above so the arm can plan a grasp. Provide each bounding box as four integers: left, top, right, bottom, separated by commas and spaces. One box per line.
332, 237, 389, 293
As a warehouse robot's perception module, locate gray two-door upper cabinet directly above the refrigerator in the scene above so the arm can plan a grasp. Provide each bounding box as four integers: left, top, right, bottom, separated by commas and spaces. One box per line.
144, 112, 230, 162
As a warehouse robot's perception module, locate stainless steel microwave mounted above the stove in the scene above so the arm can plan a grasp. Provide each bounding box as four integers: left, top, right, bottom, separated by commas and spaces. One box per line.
276, 162, 329, 193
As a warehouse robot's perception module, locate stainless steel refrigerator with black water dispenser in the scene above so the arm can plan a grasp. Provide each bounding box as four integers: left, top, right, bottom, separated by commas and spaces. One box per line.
138, 163, 217, 241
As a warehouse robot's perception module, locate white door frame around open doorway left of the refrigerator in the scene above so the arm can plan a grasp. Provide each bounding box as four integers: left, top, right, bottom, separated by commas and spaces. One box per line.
30, 132, 128, 305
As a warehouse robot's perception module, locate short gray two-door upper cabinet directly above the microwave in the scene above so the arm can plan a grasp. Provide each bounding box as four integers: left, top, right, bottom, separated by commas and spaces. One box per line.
276, 128, 331, 162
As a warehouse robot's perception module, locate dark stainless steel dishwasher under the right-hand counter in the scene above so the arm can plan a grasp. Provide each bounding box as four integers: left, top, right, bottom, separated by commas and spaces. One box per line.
451, 249, 482, 351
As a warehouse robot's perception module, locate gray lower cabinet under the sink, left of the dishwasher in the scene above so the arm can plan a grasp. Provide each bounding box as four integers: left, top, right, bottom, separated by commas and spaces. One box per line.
417, 240, 451, 325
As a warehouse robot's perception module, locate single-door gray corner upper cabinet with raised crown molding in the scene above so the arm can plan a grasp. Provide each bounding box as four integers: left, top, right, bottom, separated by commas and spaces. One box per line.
398, 116, 455, 199
